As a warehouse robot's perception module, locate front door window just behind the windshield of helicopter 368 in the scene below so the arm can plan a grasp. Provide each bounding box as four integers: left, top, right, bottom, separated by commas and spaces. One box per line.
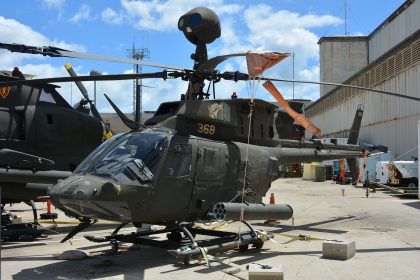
166, 143, 192, 177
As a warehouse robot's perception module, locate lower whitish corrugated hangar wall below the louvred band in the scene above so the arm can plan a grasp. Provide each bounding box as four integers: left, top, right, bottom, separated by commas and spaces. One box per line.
311, 64, 420, 159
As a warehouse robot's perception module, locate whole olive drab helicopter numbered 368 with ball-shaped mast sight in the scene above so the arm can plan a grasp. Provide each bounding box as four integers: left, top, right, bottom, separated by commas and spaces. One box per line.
0, 8, 406, 263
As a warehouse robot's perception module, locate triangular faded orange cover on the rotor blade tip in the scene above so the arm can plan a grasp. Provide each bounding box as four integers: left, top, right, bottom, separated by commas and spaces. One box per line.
246, 51, 290, 79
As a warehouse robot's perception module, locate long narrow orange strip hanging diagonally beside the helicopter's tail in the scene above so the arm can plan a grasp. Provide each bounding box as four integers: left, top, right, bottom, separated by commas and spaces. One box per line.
263, 80, 321, 136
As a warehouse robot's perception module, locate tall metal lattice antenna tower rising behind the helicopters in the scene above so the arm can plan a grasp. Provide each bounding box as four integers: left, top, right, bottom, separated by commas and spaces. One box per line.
127, 42, 150, 123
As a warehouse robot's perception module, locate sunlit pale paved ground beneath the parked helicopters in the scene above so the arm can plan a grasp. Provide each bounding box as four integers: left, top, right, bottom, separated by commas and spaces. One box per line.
1, 179, 420, 280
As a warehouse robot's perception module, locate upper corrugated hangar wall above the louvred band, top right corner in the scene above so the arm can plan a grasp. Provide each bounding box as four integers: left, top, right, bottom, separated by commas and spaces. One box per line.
369, 0, 420, 63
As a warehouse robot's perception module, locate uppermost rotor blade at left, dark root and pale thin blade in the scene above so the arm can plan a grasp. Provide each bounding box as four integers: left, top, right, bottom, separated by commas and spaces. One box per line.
0, 43, 184, 70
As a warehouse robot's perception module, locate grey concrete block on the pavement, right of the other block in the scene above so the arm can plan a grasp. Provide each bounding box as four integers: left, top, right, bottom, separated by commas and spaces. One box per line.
322, 240, 356, 260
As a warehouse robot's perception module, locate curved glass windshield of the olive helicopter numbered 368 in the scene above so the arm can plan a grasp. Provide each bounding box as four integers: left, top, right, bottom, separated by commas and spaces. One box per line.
82, 132, 168, 185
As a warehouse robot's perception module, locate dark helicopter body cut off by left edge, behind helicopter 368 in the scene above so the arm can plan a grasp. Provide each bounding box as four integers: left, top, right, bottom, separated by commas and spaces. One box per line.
0, 64, 115, 204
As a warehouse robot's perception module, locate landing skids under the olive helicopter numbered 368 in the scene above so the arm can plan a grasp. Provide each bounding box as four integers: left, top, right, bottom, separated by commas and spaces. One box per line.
84, 221, 272, 264
